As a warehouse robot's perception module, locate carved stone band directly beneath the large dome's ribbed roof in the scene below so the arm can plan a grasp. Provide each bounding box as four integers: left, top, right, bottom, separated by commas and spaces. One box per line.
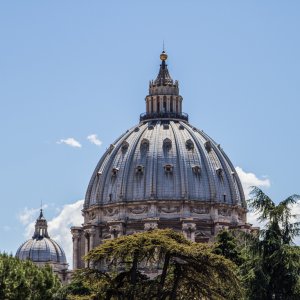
84, 200, 246, 225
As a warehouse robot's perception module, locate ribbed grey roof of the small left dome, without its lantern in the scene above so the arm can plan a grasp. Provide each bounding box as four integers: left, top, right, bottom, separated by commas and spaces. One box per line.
16, 237, 67, 264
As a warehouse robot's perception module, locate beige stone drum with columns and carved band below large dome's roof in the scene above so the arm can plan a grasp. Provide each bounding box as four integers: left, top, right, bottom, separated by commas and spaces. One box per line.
71, 200, 253, 269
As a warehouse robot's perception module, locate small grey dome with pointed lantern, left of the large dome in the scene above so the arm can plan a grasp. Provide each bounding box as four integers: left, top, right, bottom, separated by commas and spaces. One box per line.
16, 210, 67, 269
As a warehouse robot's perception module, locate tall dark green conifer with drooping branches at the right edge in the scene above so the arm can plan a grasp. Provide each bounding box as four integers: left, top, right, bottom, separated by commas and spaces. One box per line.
242, 188, 300, 300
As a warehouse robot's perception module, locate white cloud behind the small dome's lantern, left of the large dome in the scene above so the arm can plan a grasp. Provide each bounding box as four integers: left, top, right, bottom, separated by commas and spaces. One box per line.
19, 200, 84, 268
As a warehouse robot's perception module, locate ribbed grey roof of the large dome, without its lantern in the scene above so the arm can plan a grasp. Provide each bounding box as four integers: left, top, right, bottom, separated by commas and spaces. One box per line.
84, 120, 245, 208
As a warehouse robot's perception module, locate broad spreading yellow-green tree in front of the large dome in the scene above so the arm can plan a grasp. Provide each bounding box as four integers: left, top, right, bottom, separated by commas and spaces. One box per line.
68, 230, 242, 300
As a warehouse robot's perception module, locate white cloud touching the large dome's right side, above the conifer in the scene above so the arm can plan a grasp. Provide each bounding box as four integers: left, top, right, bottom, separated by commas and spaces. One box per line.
235, 167, 271, 199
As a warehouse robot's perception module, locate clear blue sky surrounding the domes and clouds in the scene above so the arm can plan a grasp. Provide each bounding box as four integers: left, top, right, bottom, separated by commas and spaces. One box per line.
0, 0, 300, 264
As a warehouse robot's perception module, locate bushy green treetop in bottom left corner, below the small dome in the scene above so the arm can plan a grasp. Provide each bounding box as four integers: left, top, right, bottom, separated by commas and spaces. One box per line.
0, 254, 60, 300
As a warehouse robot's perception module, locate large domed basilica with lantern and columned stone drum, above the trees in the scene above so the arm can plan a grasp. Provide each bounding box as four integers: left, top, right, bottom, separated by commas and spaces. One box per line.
71, 51, 251, 269
